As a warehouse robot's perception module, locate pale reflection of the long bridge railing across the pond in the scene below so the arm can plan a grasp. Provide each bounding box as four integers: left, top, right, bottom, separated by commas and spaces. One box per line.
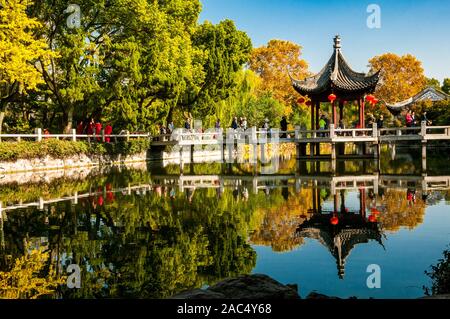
0, 174, 450, 218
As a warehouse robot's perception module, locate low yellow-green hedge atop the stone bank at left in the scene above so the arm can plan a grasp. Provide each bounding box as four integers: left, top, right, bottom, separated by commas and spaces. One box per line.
0, 139, 150, 162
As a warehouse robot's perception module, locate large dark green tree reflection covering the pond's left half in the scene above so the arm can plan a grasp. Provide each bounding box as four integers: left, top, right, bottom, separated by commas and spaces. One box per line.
0, 181, 264, 298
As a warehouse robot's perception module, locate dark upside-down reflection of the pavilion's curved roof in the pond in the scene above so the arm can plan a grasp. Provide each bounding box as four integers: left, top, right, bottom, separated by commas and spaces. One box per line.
297, 213, 384, 279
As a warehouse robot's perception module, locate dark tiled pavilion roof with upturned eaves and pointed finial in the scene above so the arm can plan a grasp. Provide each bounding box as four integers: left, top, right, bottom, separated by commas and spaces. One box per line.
291, 36, 380, 98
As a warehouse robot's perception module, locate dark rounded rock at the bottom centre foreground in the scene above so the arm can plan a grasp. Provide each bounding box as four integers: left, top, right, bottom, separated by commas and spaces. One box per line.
172, 274, 300, 299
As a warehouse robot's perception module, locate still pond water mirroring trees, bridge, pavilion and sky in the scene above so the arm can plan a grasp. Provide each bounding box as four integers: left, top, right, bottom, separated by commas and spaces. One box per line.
0, 151, 450, 298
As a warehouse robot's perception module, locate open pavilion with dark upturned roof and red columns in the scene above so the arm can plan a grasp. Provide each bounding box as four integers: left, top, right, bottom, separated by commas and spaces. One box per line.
291, 35, 380, 129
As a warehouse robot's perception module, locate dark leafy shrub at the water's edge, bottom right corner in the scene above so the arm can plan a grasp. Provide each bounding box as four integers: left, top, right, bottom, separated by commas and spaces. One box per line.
424, 245, 450, 296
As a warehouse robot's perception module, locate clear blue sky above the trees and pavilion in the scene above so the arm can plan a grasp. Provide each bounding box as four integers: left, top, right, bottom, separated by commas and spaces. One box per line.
200, 0, 450, 81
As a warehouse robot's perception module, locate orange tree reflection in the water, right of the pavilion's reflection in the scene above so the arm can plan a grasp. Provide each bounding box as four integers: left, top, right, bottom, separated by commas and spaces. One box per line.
380, 189, 426, 231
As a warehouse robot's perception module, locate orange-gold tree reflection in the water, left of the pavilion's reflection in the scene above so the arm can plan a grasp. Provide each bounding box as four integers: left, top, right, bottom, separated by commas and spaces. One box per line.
250, 189, 312, 251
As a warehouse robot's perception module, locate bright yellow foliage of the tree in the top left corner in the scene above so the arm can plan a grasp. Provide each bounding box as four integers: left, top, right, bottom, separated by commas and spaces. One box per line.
0, 0, 54, 134
